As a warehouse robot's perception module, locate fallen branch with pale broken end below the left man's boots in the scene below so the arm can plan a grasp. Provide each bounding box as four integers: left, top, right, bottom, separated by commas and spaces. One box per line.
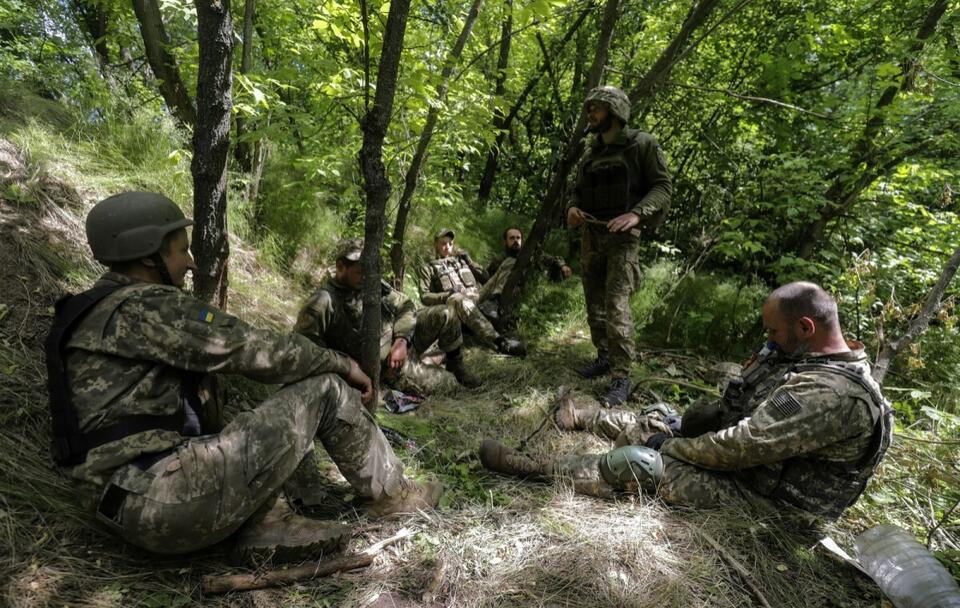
200, 528, 417, 594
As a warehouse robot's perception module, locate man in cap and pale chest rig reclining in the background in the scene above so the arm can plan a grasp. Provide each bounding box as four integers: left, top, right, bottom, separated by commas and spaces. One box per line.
420, 229, 527, 357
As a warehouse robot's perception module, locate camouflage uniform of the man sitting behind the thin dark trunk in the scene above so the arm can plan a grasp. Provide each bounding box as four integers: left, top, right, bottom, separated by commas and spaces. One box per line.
296, 277, 463, 395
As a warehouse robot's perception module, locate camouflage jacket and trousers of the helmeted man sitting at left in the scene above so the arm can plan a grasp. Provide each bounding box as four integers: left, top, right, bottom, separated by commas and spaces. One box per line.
66, 272, 404, 553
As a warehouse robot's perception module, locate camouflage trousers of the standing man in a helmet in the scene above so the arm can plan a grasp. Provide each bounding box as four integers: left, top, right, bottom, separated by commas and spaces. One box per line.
580, 226, 640, 378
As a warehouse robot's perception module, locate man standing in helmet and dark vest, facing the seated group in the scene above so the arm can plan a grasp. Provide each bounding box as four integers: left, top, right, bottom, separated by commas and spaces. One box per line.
567, 86, 673, 407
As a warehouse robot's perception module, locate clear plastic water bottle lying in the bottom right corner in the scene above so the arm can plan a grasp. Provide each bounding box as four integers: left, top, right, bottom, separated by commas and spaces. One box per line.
854, 524, 960, 608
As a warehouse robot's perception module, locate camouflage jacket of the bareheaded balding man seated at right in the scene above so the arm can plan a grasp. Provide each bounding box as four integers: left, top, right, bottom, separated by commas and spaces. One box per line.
661, 346, 892, 517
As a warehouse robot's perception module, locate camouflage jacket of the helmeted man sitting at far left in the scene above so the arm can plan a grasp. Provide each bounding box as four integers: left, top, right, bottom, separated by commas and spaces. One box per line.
65, 272, 350, 485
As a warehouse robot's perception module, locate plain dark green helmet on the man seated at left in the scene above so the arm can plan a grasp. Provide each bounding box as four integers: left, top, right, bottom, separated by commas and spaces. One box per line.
86, 192, 193, 264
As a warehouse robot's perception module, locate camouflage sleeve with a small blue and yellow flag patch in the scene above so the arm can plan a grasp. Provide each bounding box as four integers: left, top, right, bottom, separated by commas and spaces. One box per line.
111, 288, 350, 383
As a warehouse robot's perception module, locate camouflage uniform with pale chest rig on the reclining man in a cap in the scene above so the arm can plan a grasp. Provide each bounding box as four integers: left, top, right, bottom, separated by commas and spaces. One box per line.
420, 255, 500, 344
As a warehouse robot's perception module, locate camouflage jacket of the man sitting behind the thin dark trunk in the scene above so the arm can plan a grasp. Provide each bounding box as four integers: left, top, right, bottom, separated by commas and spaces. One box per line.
296, 277, 417, 361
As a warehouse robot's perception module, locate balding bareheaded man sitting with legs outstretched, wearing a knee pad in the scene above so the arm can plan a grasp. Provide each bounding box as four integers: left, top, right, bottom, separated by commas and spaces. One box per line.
480, 282, 893, 522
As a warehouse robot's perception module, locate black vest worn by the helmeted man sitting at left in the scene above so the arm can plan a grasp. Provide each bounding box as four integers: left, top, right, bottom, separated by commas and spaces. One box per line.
44, 285, 183, 466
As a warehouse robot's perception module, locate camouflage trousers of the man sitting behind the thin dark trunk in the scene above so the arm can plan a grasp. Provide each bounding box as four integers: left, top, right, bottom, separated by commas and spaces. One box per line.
383, 305, 463, 395
